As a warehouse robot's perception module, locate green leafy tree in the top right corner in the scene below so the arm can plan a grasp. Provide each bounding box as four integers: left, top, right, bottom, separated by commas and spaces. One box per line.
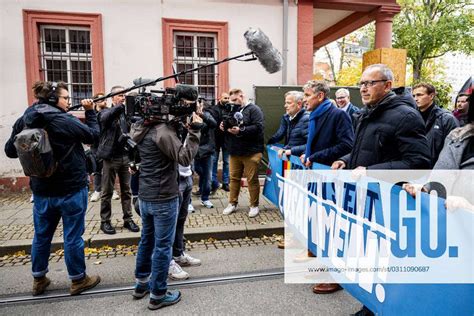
393, 0, 474, 82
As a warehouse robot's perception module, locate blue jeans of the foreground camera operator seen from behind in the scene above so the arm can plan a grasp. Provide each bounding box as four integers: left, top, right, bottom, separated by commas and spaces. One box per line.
135, 197, 179, 296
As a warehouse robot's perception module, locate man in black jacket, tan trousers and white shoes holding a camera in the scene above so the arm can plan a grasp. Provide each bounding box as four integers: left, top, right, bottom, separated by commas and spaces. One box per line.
220, 89, 264, 217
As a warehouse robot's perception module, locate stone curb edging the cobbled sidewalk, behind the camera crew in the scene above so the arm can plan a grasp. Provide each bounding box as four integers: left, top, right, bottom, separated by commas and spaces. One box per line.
0, 222, 284, 256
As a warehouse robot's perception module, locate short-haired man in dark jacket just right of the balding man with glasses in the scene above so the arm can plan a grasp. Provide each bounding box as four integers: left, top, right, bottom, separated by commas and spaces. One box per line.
413, 83, 459, 168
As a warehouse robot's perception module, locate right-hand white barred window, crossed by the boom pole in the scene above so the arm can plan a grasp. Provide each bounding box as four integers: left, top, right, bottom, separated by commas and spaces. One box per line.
173, 32, 218, 100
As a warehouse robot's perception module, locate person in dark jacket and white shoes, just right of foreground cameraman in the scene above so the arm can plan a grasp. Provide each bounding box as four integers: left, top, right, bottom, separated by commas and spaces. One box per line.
194, 101, 217, 208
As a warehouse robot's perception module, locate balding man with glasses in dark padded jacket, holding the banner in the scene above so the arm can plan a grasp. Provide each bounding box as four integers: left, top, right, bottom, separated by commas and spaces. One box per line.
332, 64, 431, 169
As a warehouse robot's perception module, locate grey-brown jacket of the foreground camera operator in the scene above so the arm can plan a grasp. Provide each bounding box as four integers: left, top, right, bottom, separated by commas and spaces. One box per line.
131, 123, 200, 202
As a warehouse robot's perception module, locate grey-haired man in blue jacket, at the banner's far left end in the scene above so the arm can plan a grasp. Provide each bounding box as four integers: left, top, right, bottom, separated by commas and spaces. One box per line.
268, 91, 309, 158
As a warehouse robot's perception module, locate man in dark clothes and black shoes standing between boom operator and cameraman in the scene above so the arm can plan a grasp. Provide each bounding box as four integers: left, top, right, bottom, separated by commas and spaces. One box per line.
97, 86, 140, 234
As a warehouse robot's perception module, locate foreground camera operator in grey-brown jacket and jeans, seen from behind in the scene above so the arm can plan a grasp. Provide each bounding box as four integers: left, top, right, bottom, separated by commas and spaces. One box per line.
132, 108, 203, 310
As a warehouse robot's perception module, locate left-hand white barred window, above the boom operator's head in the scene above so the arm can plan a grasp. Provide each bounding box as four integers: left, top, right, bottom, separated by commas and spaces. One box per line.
40, 25, 93, 104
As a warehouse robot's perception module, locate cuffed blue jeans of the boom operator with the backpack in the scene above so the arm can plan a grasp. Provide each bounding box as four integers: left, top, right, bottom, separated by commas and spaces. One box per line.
31, 187, 87, 280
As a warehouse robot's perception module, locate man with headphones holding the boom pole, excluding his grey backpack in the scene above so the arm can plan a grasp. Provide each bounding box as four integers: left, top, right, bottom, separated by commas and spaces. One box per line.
5, 81, 100, 295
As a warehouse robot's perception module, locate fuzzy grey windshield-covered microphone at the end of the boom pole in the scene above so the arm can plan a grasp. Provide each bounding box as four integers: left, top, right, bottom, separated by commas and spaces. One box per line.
244, 28, 283, 74
